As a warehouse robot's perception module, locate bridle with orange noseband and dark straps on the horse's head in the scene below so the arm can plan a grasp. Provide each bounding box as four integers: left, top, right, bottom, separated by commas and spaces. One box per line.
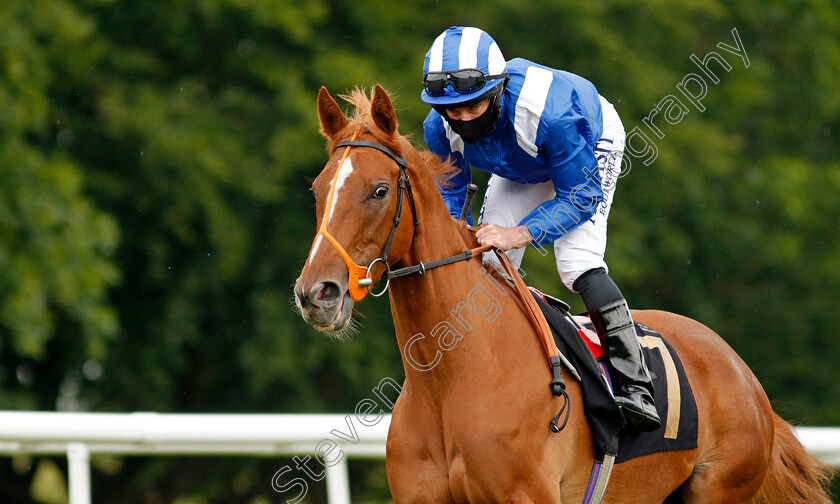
313, 129, 490, 302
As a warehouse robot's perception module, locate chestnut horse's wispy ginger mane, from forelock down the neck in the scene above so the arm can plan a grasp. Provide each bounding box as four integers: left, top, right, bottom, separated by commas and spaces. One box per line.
327, 86, 457, 187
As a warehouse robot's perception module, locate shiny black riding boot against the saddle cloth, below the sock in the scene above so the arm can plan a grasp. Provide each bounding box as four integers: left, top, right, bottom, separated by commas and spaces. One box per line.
589, 299, 661, 432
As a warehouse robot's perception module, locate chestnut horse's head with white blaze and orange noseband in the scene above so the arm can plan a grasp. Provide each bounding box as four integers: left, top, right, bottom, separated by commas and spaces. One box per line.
294, 85, 417, 331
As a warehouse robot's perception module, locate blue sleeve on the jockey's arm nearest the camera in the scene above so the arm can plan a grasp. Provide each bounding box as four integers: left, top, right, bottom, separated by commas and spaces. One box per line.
520, 117, 604, 247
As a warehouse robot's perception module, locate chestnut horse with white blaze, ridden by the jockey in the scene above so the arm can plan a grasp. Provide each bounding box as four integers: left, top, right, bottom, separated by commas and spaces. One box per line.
294, 85, 830, 504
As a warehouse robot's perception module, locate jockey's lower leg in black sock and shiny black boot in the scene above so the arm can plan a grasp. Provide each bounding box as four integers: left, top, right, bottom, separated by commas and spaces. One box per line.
573, 268, 661, 432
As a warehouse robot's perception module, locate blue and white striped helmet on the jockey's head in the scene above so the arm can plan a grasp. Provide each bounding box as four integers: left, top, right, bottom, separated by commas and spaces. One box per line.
420, 26, 506, 106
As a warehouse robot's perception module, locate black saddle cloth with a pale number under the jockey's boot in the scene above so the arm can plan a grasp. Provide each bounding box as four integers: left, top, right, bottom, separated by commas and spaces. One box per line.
534, 294, 698, 463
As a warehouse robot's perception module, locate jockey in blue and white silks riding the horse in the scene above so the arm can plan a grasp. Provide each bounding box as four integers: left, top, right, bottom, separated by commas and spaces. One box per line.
420, 26, 660, 431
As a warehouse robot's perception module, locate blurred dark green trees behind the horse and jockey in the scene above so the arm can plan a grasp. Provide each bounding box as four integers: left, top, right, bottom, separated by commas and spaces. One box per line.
0, 0, 840, 504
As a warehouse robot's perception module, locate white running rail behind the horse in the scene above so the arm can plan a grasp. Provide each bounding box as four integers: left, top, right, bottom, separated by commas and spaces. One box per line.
0, 411, 840, 504
